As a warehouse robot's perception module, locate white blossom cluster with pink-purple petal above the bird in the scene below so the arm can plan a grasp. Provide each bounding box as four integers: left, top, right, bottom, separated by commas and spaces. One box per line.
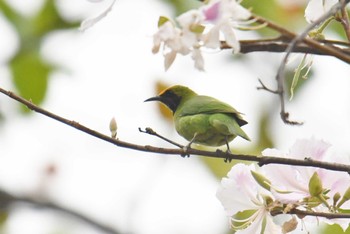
152, 0, 251, 70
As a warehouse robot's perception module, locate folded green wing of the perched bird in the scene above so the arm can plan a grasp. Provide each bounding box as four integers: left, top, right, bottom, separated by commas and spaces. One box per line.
179, 95, 247, 126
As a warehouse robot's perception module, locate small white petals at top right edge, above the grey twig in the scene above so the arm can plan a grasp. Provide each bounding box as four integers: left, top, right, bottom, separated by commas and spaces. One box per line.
305, 0, 338, 23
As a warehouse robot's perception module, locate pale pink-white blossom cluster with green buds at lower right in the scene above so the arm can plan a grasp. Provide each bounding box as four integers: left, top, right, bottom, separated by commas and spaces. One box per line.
217, 138, 350, 233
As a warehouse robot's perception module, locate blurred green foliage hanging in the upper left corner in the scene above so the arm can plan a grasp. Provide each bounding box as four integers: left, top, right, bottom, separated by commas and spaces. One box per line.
0, 0, 79, 110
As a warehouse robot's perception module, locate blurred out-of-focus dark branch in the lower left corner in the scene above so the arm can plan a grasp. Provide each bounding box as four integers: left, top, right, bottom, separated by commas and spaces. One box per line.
0, 189, 120, 234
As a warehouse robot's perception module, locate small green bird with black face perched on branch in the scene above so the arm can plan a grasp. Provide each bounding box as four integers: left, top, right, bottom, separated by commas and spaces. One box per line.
145, 85, 250, 151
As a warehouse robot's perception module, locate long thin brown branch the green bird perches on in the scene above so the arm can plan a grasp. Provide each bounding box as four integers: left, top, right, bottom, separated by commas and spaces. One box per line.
0, 87, 350, 173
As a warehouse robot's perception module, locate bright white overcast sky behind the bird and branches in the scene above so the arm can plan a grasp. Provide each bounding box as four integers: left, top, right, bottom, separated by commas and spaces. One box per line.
0, 0, 350, 234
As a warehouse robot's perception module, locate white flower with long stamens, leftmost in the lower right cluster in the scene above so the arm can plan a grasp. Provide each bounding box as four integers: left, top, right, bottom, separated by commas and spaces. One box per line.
216, 163, 282, 234
